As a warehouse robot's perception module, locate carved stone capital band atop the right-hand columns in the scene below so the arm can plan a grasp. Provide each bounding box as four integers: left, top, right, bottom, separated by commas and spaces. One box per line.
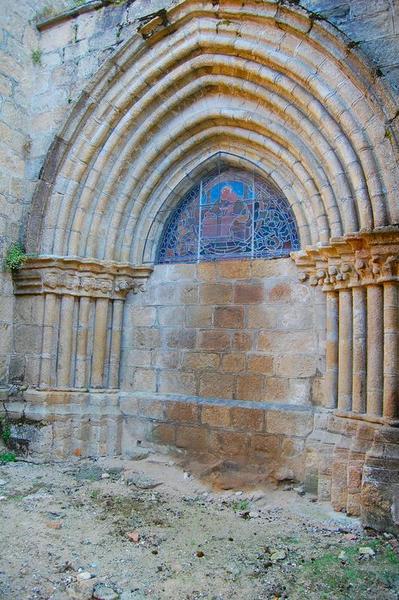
291, 227, 399, 291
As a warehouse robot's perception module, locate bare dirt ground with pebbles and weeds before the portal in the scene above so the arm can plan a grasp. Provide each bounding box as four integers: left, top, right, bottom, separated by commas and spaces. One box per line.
0, 451, 399, 600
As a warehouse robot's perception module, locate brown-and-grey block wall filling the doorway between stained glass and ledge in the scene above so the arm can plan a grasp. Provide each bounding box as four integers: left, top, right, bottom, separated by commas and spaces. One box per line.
121, 258, 324, 404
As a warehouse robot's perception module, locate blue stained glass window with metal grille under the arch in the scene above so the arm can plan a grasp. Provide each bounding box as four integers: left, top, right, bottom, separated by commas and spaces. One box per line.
157, 167, 299, 263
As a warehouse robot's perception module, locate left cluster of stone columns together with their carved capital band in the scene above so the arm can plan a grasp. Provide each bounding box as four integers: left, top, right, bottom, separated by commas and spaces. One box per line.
15, 256, 152, 390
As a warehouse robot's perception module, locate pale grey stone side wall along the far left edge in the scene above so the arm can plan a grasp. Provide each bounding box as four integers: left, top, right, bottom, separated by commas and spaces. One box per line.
0, 0, 39, 384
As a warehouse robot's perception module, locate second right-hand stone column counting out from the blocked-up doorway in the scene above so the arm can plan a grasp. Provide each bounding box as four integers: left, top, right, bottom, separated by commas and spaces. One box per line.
338, 289, 352, 411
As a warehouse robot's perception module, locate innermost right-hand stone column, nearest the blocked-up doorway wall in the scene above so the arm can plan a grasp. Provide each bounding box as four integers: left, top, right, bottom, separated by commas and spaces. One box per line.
325, 292, 338, 408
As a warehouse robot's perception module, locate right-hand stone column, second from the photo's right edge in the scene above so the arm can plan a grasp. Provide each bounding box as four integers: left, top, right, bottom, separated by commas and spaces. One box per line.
367, 285, 383, 416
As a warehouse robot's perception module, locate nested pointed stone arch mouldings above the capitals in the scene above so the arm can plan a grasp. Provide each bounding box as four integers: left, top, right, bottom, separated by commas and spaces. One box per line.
27, 0, 399, 263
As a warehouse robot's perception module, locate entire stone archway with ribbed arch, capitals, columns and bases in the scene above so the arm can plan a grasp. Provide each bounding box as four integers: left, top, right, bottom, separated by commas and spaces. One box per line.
11, 0, 399, 532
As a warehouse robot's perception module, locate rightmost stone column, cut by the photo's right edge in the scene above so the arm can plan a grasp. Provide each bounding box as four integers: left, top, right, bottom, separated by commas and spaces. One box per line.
383, 282, 399, 418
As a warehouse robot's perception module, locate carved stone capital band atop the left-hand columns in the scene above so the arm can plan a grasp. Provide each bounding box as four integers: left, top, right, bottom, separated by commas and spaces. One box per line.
14, 256, 152, 299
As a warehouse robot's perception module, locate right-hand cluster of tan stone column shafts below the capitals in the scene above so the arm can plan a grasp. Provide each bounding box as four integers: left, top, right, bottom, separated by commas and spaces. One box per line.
325, 282, 399, 419
